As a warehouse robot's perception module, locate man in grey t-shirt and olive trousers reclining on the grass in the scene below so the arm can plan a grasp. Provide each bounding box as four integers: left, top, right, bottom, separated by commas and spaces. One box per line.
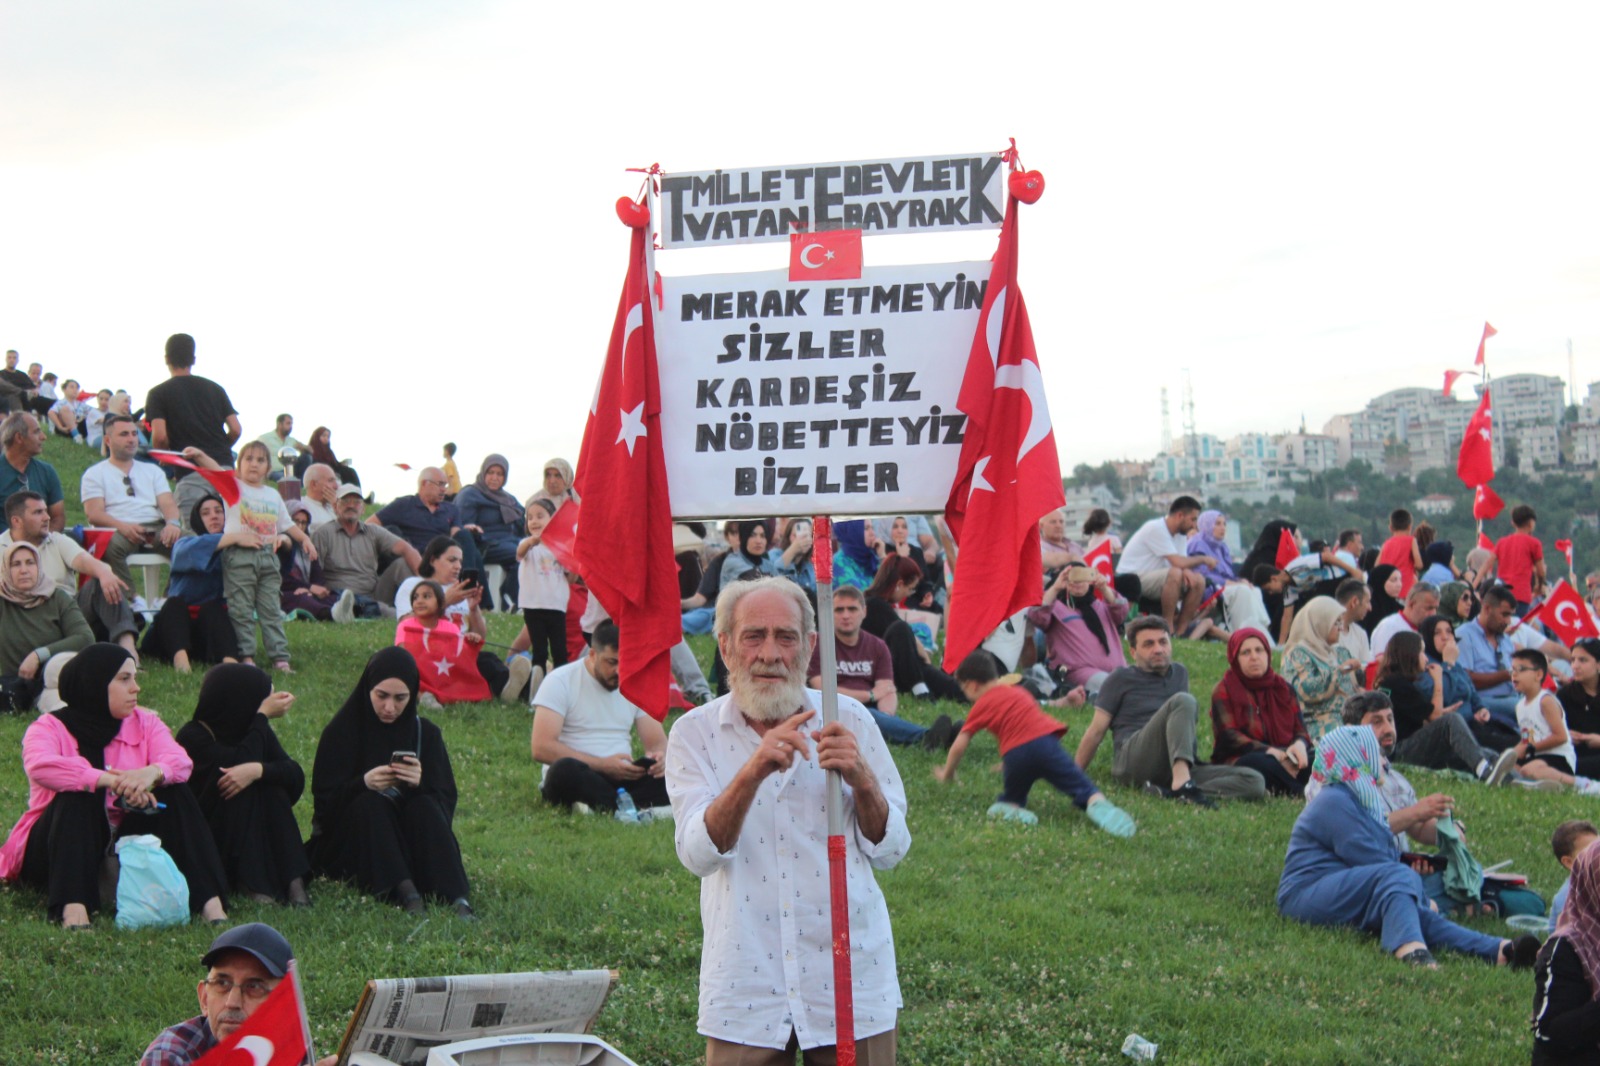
1077, 615, 1267, 807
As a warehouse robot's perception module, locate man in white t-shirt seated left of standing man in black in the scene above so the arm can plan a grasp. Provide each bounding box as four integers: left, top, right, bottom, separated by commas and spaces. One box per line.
80, 415, 184, 583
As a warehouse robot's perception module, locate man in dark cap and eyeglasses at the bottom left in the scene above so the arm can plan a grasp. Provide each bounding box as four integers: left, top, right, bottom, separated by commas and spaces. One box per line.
139, 922, 339, 1066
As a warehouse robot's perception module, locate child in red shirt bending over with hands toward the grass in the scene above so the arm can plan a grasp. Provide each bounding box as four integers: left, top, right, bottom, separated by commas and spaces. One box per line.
933, 648, 1134, 837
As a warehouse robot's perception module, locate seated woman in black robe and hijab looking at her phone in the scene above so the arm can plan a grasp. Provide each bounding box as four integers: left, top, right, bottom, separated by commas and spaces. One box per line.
307, 647, 472, 919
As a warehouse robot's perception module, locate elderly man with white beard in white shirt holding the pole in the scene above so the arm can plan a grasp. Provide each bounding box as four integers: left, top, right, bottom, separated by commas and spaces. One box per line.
667, 578, 910, 1066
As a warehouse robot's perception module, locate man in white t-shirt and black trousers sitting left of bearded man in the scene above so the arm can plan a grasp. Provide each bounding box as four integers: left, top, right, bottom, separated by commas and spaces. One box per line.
533, 621, 667, 815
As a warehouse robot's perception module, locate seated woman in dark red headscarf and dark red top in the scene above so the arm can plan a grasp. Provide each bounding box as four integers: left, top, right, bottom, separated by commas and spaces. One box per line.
1211, 629, 1310, 795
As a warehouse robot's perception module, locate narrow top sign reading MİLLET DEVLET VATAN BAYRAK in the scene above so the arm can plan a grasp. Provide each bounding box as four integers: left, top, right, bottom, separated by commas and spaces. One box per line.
661, 152, 1006, 248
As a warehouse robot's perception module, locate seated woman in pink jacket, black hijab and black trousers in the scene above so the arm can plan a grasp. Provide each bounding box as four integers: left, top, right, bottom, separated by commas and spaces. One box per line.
0, 643, 227, 930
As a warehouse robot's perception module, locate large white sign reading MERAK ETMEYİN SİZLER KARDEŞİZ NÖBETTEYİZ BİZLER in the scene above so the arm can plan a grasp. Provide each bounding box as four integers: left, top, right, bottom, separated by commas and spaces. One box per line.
654, 262, 990, 519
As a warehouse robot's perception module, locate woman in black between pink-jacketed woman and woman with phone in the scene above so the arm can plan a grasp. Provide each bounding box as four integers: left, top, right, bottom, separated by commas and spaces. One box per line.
178, 663, 310, 906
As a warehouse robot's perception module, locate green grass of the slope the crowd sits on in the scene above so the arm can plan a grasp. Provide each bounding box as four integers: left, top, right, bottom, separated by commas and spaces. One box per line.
0, 442, 1574, 1064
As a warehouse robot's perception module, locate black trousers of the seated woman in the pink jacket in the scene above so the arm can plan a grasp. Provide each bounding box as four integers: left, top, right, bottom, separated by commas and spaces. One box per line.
19, 784, 227, 920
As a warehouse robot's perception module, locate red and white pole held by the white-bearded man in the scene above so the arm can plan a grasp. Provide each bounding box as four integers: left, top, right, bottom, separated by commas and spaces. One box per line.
811, 514, 856, 1066
